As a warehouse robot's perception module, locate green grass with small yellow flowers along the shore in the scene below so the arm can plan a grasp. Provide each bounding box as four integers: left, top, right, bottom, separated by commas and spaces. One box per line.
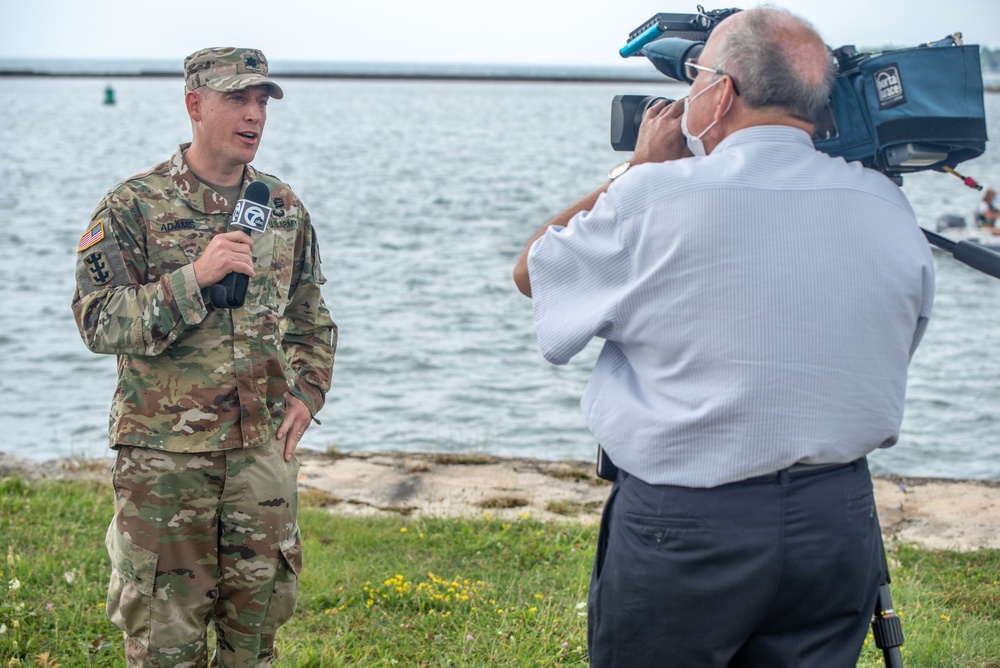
0, 479, 1000, 668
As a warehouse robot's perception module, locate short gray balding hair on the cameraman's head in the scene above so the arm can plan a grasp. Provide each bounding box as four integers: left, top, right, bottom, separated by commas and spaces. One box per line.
713, 8, 836, 123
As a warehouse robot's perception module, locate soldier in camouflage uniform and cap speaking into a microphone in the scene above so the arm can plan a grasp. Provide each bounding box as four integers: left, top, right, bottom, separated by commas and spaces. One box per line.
73, 48, 337, 668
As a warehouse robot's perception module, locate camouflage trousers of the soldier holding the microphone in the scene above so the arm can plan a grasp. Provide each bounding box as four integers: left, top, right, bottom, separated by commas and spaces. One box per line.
106, 440, 302, 668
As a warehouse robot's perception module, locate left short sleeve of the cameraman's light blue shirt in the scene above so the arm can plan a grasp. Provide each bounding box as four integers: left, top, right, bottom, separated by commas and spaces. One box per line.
528, 188, 630, 364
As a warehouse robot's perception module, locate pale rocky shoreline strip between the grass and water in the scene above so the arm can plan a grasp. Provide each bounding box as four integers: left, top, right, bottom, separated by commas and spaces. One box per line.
0, 449, 1000, 551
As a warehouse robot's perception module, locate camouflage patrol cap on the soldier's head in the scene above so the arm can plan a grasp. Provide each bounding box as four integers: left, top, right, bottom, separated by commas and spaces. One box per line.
184, 46, 285, 100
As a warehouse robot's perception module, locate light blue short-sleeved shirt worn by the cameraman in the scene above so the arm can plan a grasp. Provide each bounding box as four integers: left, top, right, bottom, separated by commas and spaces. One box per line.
528, 126, 934, 487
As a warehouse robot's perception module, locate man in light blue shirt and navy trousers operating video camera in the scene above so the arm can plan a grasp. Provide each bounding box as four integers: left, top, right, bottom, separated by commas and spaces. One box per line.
514, 8, 934, 668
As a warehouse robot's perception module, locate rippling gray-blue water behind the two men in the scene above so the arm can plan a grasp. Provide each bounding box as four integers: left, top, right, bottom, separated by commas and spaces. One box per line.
0, 78, 1000, 479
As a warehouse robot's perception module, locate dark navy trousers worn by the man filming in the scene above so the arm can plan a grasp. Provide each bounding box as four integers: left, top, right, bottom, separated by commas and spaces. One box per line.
588, 460, 882, 668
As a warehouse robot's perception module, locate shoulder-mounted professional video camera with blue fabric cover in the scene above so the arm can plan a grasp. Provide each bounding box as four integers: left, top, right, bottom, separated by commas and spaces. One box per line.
611, 5, 986, 181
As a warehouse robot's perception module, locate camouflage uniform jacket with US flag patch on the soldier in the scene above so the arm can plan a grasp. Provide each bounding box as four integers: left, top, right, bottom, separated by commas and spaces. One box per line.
73, 144, 337, 452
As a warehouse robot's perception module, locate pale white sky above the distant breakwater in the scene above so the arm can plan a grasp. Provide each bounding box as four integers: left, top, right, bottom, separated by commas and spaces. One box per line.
0, 0, 1000, 66
